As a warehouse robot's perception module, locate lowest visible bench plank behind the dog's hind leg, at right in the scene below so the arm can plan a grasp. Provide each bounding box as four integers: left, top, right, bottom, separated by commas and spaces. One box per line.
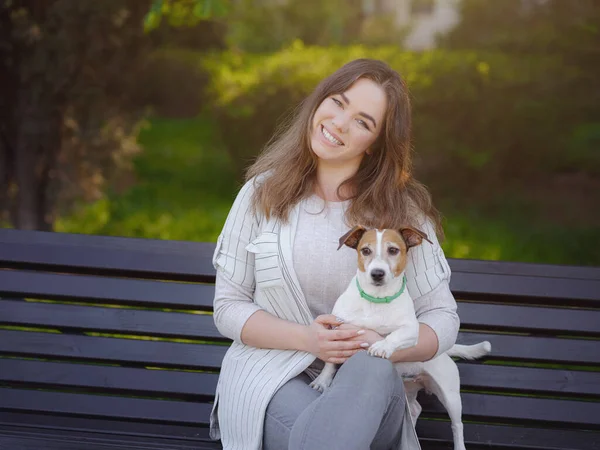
416, 419, 600, 450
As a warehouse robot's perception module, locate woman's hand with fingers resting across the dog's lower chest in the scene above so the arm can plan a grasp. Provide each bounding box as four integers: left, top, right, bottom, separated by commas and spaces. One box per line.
306, 314, 369, 364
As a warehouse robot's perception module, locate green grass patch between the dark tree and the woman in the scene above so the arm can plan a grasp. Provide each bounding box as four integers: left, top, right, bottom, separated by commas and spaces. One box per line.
55, 119, 236, 241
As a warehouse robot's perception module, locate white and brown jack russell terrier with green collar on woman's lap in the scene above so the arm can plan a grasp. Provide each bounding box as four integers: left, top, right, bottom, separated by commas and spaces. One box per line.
311, 226, 491, 450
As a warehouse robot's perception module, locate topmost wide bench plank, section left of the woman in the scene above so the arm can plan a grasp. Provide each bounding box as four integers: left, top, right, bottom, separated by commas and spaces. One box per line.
0, 229, 215, 282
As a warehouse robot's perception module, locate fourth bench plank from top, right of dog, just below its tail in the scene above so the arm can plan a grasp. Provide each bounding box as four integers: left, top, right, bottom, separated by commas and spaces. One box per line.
458, 362, 600, 397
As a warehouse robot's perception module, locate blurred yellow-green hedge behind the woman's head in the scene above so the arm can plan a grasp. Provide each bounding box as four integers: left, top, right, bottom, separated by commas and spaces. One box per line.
203, 42, 580, 183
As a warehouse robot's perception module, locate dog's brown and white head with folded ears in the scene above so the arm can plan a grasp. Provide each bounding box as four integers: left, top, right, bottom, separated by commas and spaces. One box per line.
338, 225, 431, 286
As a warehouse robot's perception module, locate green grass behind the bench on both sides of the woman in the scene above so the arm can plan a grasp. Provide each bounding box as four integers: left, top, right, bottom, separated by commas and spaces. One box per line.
55, 117, 600, 265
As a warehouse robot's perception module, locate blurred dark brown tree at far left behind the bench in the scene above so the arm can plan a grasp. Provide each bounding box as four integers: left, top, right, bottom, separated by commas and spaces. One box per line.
0, 0, 226, 230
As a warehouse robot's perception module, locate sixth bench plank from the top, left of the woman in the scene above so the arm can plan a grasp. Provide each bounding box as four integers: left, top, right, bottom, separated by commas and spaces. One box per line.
0, 388, 212, 426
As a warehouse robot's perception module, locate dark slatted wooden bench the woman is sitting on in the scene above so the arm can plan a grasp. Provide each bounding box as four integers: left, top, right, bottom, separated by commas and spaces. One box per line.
0, 230, 600, 450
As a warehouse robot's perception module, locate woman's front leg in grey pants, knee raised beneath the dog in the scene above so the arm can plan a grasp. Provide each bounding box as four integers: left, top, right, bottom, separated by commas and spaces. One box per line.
290, 352, 405, 450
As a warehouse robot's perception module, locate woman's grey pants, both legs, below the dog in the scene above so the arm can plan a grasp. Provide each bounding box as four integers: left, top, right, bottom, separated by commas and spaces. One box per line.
263, 351, 405, 450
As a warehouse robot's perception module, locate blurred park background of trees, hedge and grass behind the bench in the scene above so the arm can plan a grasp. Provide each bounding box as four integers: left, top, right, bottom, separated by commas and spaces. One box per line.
0, 0, 600, 266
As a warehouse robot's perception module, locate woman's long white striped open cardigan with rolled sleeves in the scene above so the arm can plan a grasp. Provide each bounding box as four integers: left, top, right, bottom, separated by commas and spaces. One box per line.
210, 180, 459, 450
